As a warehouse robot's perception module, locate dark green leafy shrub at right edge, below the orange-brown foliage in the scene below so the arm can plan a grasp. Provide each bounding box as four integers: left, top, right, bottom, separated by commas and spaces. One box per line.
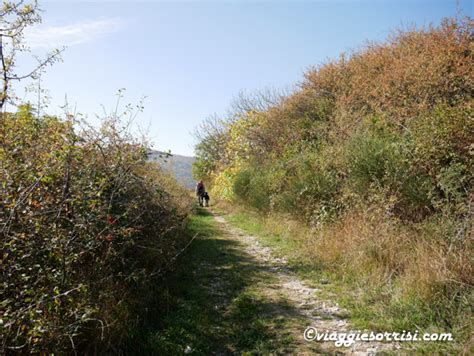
408, 100, 474, 215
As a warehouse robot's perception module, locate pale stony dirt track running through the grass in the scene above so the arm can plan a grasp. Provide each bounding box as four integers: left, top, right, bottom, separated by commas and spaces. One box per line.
210, 213, 399, 355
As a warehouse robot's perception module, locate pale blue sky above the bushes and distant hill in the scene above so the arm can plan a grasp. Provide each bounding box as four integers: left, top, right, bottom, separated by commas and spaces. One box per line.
27, 0, 472, 155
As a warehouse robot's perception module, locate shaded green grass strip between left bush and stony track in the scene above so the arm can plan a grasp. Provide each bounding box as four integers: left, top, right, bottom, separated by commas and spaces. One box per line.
125, 209, 300, 355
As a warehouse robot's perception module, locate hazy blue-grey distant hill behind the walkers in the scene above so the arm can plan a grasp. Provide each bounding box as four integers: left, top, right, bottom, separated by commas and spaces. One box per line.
148, 151, 196, 189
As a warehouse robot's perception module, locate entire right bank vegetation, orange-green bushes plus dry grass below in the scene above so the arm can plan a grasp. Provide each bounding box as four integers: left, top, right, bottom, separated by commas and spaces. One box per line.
194, 18, 474, 350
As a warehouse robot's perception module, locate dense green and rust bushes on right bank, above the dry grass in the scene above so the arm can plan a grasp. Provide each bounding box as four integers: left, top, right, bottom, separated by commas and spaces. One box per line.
196, 18, 474, 221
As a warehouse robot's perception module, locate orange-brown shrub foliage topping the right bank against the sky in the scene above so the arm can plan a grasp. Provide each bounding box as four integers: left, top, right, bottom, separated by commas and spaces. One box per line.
303, 18, 473, 130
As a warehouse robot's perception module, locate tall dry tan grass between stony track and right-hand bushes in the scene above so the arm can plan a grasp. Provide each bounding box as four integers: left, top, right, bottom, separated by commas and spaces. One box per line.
217, 203, 474, 354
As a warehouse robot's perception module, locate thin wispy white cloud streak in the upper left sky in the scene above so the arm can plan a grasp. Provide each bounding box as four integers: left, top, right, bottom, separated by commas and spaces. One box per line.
25, 19, 123, 48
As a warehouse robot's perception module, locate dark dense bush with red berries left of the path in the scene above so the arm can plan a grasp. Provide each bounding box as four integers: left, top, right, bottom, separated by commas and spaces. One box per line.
0, 106, 193, 352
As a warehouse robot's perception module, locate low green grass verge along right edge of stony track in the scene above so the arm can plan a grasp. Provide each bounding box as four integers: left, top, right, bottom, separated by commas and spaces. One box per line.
215, 204, 472, 354
